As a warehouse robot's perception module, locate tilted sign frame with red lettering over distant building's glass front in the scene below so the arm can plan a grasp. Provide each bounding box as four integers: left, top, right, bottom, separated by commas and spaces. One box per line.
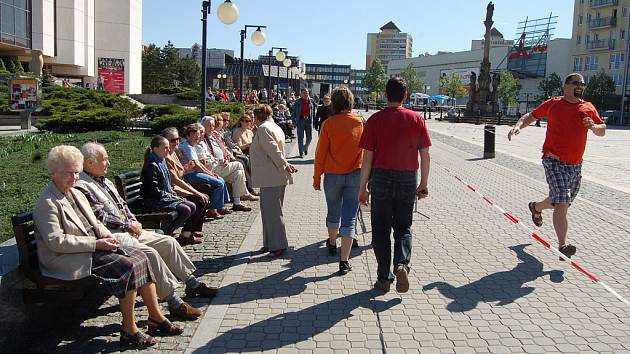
507, 14, 558, 78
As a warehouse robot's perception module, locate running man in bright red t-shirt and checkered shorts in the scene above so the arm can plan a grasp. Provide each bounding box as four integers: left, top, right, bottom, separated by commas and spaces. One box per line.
508, 73, 606, 260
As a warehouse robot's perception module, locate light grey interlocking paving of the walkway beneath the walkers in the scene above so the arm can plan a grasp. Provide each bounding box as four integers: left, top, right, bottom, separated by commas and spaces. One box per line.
187, 131, 630, 353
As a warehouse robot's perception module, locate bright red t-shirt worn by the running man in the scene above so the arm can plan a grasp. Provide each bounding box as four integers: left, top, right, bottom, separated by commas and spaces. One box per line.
532, 96, 604, 164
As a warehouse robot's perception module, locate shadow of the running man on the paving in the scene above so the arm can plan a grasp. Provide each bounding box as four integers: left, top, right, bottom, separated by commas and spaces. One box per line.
422, 244, 564, 312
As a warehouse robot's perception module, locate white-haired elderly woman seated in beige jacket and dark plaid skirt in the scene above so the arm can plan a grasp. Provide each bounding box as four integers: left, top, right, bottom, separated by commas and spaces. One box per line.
33, 145, 183, 348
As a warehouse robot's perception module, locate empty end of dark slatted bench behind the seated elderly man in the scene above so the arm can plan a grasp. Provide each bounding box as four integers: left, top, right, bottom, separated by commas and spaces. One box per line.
114, 170, 177, 229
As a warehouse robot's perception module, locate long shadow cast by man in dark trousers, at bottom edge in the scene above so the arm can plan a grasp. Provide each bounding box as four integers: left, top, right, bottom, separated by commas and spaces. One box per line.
192, 289, 402, 354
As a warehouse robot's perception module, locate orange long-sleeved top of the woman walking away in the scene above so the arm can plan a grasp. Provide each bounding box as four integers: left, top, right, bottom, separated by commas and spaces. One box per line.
313, 112, 363, 185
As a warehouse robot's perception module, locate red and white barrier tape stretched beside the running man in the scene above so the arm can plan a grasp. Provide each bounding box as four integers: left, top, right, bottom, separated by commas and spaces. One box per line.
450, 167, 630, 306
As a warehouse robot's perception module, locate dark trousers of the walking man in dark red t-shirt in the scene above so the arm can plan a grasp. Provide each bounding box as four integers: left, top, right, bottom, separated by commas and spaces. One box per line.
370, 168, 418, 280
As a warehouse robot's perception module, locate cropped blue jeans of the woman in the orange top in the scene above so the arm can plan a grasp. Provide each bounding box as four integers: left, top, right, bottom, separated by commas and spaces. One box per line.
324, 169, 361, 237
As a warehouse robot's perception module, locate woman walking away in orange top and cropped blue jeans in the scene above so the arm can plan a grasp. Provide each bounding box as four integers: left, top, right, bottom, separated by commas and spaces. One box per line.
313, 86, 363, 275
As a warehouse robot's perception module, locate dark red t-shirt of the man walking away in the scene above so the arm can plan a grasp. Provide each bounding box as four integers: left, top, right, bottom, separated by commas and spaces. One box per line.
359, 107, 431, 171
